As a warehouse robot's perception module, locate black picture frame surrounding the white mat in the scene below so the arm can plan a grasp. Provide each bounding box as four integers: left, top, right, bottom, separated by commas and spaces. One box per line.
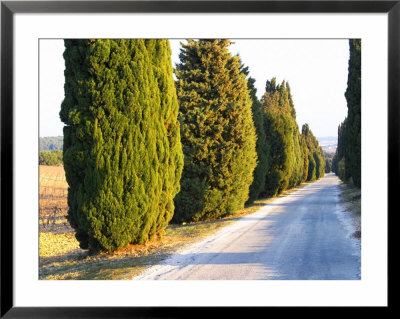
0, 0, 394, 318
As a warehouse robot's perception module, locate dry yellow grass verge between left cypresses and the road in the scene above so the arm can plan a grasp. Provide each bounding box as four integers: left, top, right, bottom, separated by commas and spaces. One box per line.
39, 184, 306, 280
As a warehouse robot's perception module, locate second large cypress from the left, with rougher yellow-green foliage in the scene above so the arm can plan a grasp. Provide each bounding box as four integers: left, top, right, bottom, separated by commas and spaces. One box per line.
174, 40, 257, 222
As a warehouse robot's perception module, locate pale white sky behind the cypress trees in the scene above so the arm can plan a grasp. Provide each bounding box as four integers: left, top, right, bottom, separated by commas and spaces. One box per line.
39, 39, 349, 137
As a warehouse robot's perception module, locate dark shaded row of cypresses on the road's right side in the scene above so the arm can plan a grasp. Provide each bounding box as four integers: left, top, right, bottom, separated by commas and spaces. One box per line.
332, 39, 361, 188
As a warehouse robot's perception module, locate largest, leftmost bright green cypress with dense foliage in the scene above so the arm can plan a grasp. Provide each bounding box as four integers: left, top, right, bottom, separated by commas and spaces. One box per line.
60, 39, 183, 251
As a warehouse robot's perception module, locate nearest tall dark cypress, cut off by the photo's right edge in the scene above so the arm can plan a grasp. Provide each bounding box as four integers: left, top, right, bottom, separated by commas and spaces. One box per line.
345, 39, 361, 187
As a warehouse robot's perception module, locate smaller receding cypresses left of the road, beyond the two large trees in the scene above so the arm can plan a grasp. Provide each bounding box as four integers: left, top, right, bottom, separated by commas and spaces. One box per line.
244, 78, 325, 202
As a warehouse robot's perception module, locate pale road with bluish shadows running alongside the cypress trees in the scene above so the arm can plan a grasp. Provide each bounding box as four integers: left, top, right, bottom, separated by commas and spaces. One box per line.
133, 174, 360, 280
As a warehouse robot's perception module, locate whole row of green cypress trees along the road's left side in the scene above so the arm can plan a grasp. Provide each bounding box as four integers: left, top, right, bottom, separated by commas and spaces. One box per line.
60, 39, 325, 251
